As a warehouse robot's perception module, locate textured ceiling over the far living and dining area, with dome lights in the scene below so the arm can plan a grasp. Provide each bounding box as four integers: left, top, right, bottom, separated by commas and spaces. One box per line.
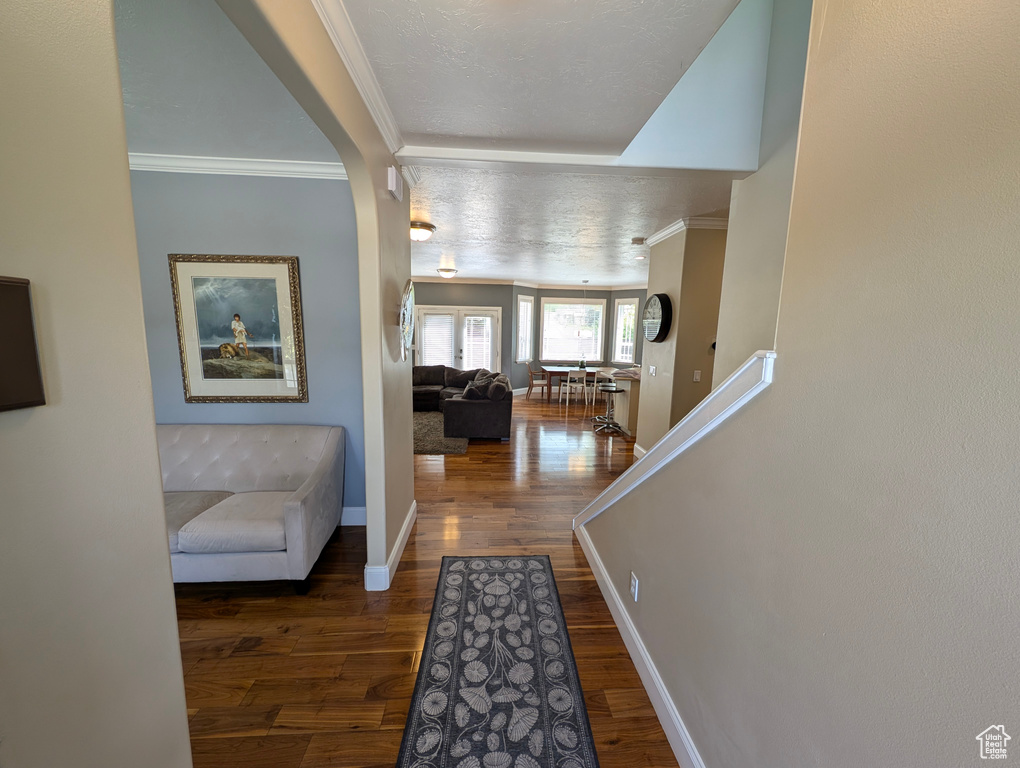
411, 167, 747, 287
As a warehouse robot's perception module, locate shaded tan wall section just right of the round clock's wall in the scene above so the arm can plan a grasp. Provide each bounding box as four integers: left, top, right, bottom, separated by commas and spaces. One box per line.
669, 229, 726, 426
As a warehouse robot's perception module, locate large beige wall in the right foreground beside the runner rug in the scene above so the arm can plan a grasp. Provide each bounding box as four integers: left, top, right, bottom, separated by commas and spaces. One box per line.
588, 0, 1020, 768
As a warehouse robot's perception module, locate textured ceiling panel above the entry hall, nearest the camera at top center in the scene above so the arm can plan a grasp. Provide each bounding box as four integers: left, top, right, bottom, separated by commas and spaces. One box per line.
344, 0, 736, 155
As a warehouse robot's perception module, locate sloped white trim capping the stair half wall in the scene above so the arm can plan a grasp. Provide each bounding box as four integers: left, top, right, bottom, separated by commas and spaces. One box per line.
573, 350, 775, 529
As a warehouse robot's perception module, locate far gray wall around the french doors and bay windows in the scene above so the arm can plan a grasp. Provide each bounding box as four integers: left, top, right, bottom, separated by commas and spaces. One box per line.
414, 283, 647, 388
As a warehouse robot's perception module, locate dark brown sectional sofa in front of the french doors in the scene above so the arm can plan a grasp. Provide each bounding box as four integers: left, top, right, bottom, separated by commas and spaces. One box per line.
411, 365, 513, 440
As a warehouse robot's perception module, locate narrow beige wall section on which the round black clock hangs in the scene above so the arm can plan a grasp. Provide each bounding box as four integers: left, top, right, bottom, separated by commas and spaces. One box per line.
634, 229, 689, 451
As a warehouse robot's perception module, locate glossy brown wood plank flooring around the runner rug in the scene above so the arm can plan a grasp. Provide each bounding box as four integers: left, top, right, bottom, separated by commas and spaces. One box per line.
176, 396, 676, 768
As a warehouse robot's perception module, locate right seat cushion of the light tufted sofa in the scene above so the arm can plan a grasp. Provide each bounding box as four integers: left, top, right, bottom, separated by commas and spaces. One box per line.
177, 491, 292, 555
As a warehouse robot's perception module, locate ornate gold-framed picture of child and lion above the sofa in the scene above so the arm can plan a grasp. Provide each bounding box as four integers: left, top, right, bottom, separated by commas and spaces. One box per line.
169, 254, 308, 403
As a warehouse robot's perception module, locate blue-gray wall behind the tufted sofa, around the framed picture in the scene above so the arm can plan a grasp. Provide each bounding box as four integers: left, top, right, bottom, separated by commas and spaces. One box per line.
132, 171, 365, 507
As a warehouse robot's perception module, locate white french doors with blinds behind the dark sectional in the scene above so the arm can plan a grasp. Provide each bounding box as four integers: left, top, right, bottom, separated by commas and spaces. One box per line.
414, 306, 502, 370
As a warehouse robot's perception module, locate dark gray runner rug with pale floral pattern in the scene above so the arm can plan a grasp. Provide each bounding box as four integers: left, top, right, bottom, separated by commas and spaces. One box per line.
397, 555, 599, 768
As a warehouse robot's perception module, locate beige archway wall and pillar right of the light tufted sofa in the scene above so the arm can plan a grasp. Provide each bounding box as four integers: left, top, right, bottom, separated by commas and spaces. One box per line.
217, 0, 414, 567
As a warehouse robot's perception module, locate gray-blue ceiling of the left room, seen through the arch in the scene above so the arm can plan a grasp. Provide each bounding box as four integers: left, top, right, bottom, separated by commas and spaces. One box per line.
114, 0, 339, 162
